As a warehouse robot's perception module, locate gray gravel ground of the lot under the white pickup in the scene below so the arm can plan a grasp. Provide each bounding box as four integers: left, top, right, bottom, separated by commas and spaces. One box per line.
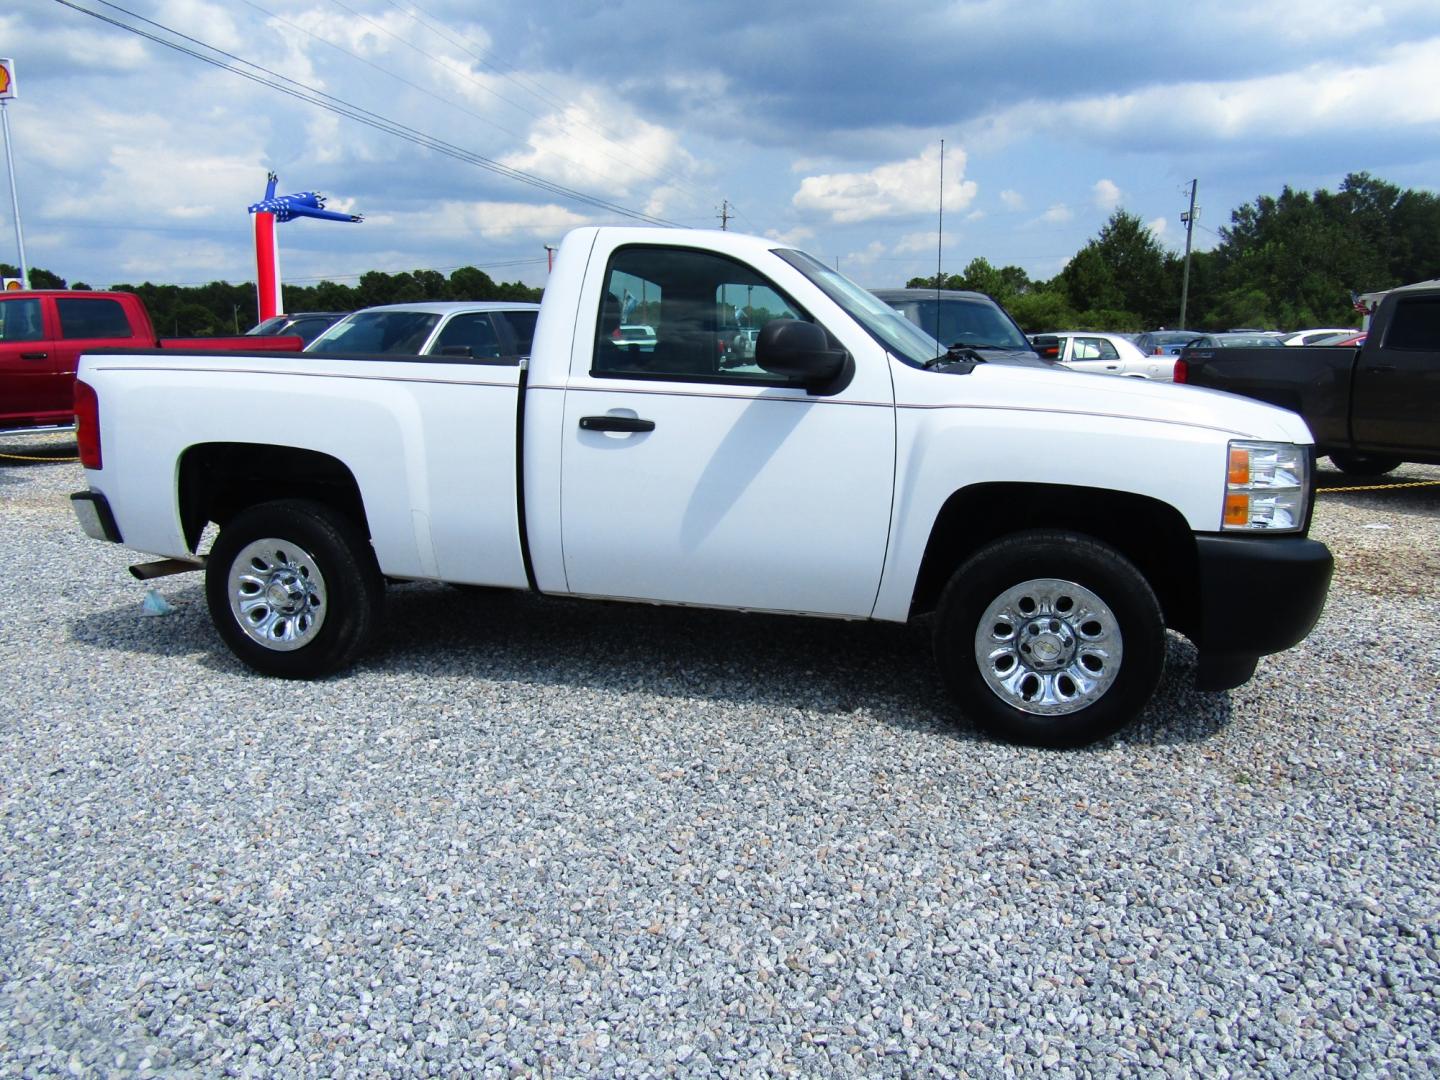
0, 442, 1440, 1077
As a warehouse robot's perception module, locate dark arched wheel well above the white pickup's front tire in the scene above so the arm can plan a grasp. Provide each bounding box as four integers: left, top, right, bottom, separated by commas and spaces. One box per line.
910, 484, 1198, 631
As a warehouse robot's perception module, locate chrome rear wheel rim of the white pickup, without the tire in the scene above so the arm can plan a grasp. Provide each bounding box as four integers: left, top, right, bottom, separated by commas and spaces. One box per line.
229, 537, 327, 652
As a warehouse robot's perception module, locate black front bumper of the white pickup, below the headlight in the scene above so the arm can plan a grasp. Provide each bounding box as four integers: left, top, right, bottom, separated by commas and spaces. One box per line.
1195, 536, 1335, 667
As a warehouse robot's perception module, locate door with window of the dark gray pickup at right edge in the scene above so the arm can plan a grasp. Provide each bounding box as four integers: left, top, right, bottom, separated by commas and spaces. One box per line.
1351, 294, 1440, 455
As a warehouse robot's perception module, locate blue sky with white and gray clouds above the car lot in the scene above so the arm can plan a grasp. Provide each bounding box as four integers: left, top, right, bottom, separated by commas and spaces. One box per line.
0, 0, 1440, 305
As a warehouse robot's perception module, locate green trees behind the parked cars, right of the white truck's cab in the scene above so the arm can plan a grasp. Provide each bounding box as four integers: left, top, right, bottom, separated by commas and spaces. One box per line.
907, 173, 1440, 333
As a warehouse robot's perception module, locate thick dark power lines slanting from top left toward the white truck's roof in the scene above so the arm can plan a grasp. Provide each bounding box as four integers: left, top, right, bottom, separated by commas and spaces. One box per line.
55, 0, 677, 226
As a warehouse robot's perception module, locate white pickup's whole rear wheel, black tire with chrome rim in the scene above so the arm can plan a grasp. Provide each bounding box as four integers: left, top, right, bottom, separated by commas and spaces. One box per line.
204, 498, 384, 678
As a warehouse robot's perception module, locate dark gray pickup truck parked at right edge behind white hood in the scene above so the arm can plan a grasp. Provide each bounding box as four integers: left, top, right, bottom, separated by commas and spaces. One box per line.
1175, 288, 1440, 477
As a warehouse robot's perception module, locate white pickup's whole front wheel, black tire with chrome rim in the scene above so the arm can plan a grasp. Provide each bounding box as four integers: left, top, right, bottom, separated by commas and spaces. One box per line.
935, 530, 1165, 747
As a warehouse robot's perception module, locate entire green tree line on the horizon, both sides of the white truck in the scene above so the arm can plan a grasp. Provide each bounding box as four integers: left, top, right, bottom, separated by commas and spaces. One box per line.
11, 173, 1440, 337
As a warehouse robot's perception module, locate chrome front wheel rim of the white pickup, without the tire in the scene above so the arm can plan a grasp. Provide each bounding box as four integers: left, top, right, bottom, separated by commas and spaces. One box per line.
975, 577, 1125, 716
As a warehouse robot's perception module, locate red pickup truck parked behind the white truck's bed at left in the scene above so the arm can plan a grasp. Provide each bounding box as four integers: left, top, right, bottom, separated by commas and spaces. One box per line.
0, 289, 304, 435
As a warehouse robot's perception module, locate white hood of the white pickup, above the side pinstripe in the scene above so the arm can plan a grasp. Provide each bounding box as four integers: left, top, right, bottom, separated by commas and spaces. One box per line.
896, 363, 1315, 444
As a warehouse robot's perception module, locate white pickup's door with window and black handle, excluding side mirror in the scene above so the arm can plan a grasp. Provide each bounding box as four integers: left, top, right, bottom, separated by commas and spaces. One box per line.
560, 245, 896, 616
